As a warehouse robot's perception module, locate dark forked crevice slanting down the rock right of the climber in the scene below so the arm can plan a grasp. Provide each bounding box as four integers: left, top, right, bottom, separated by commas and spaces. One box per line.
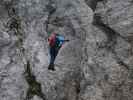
92, 14, 129, 70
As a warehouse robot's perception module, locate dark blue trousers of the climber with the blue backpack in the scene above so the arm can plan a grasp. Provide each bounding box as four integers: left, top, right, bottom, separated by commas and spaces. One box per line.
50, 46, 60, 65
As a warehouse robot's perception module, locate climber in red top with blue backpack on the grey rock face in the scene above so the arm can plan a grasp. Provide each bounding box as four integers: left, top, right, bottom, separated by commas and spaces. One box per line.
48, 33, 69, 71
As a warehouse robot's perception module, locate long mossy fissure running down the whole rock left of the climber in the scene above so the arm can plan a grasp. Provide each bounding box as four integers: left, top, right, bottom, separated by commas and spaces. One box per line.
7, 6, 46, 100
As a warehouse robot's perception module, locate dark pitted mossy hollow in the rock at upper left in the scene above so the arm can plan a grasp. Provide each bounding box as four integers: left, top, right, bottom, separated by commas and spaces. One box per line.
5, 7, 25, 49
